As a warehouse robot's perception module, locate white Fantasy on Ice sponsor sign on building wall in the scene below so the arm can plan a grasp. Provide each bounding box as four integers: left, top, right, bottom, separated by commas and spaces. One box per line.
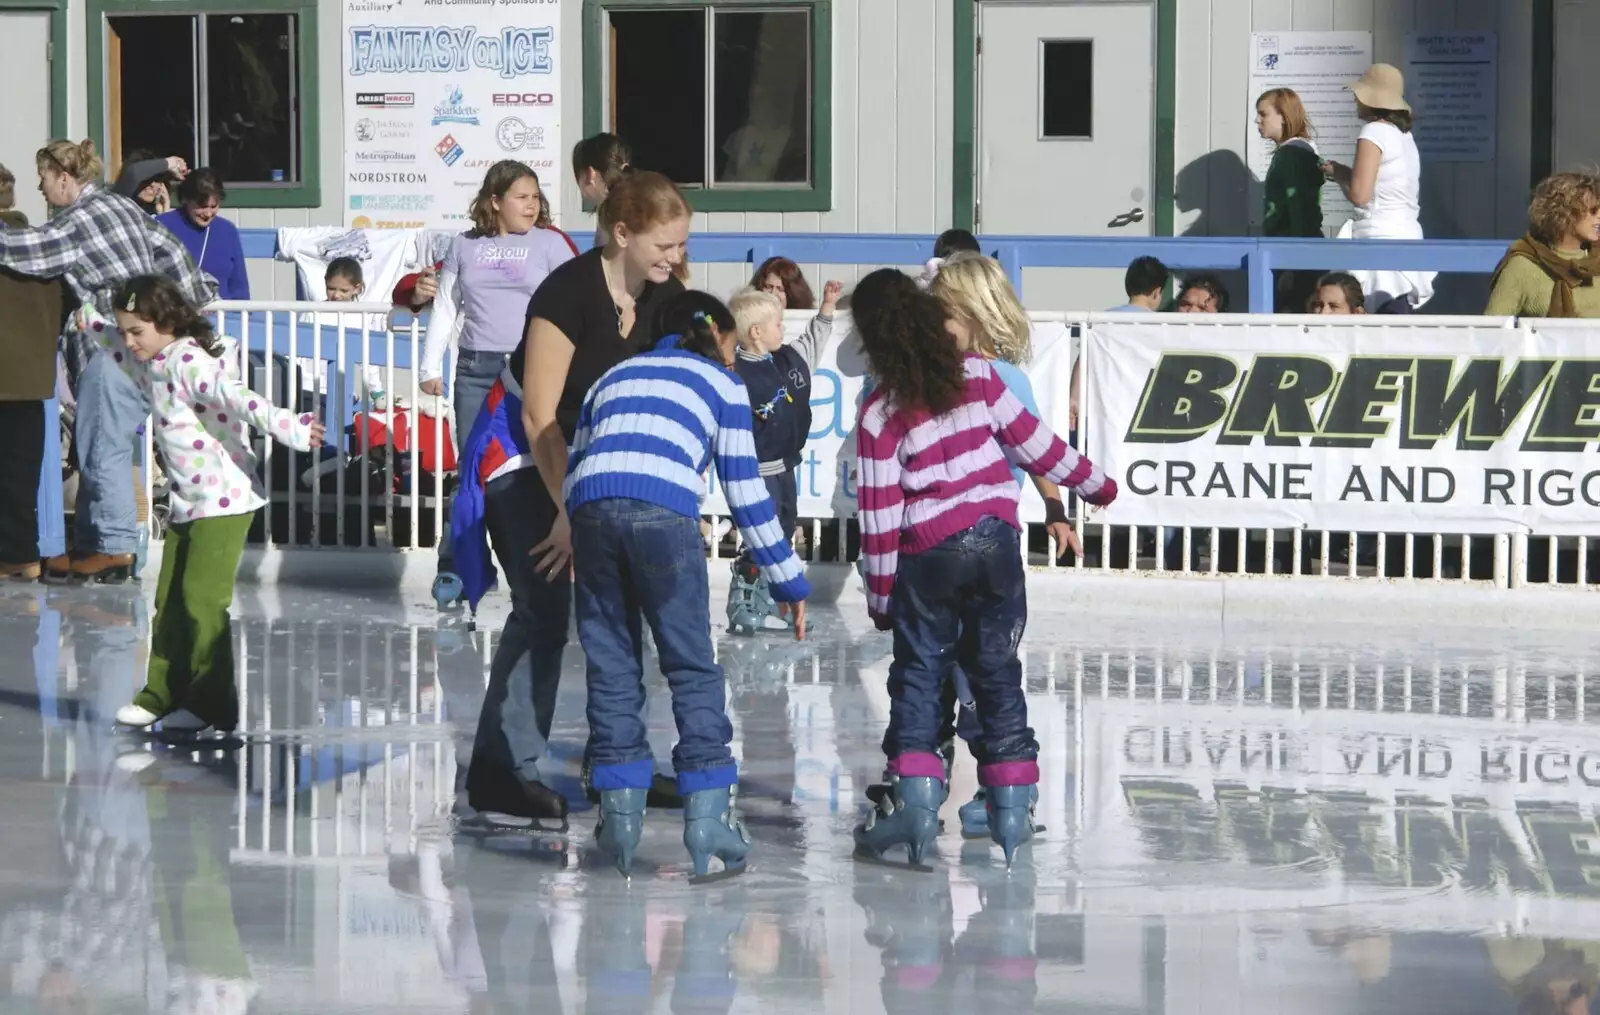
342, 0, 565, 229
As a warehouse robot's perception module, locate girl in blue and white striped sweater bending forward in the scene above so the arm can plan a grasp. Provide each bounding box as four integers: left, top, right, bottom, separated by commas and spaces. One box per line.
565, 291, 811, 881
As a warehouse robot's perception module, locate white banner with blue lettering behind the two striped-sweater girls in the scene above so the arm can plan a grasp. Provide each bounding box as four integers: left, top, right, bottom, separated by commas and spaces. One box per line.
704, 312, 1074, 522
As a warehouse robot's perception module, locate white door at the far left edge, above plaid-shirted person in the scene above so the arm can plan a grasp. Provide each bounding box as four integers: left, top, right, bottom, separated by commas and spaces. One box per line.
0, 11, 50, 226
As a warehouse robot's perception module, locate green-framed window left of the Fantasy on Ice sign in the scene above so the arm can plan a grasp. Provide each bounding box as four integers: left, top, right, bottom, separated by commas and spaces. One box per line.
90, 0, 320, 208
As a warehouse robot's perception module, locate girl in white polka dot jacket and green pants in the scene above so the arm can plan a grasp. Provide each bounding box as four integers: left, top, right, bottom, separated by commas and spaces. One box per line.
78, 275, 323, 733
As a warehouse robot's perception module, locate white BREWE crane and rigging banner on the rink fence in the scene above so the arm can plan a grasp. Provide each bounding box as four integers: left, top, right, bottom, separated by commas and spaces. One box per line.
1086, 322, 1600, 535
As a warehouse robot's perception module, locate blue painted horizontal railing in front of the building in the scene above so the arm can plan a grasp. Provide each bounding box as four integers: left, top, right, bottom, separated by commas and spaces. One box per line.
240, 229, 1507, 314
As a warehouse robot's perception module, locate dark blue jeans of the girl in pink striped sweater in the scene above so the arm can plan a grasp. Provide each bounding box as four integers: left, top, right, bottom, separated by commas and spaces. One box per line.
883, 519, 1038, 771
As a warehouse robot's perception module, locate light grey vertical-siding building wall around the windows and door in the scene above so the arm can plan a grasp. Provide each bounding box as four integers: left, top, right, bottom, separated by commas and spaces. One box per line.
50, 0, 1561, 298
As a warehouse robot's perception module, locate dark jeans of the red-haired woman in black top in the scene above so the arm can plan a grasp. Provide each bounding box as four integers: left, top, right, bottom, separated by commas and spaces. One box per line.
467, 469, 571, 790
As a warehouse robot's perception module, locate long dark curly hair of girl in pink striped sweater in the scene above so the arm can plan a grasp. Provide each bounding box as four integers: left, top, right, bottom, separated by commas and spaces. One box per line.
850, 267, 966, 416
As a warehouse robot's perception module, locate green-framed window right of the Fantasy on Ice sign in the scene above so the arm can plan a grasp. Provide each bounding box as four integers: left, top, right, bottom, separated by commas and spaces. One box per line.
584, 0, 832, 211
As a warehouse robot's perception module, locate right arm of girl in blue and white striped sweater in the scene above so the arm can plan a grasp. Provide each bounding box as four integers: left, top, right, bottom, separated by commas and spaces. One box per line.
712, 384, 811, 605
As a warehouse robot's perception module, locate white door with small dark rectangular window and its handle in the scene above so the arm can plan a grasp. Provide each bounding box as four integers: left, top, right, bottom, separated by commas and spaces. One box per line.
978, 0, 1155, 311
